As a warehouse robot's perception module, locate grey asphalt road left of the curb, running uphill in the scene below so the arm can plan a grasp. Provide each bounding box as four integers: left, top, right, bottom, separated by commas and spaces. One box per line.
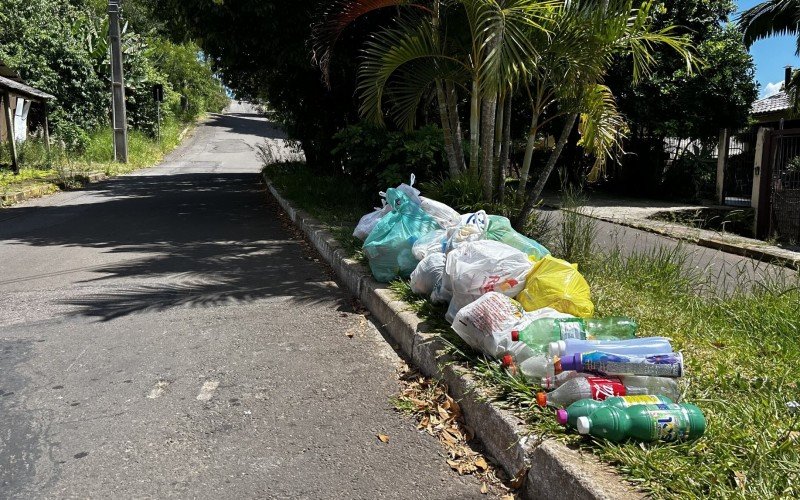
0, 103, 491, 498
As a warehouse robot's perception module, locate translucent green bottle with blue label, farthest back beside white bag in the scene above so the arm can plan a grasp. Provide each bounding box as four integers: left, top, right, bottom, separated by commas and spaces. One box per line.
514, 317, 636, 352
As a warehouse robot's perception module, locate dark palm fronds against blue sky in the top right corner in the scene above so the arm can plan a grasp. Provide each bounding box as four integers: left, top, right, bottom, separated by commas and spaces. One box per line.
739, 0, 800, 54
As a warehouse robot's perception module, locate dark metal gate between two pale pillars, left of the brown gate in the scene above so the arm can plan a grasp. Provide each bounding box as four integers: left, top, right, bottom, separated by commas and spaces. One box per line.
722, 129, 756, 207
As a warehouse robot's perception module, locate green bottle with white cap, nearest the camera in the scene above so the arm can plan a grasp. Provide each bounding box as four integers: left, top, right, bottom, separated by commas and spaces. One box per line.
576, 403, 706, 441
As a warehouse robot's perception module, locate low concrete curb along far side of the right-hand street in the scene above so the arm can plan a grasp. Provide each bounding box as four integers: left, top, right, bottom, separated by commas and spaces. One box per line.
548, 205, 800, 271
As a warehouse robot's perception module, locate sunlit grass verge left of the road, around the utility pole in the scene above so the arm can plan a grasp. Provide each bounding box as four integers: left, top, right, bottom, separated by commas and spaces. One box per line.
0, 121, 186, 202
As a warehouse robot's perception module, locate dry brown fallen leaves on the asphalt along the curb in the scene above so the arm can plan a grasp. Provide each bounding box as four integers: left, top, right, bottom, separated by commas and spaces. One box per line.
393, 366, 518, 500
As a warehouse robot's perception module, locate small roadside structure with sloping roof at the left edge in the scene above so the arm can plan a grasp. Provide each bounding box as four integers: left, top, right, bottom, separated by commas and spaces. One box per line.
0, 61, 54, 172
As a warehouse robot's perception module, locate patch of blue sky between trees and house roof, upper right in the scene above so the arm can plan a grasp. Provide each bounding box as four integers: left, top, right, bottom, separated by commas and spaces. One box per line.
737, 0, 800, 97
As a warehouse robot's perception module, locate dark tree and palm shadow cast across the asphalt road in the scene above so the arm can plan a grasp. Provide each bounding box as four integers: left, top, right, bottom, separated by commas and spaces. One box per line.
0, 173, 352, 321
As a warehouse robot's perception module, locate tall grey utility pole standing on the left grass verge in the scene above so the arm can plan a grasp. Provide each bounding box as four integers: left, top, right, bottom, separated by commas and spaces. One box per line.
108, 0, 128, 163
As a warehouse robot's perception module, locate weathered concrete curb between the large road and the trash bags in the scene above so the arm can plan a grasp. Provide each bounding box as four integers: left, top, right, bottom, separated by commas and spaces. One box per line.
264, 178, 643, 500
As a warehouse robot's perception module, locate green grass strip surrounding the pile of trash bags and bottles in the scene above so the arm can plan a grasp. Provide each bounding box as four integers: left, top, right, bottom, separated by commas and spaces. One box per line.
264, 162, 800, 498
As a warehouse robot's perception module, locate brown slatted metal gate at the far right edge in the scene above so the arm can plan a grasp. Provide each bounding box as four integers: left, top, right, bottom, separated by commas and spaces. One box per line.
765, 129, 800, 244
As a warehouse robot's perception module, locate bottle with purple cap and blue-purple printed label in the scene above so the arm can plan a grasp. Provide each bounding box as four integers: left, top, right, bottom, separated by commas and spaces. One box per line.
555, 351, 683, 377
